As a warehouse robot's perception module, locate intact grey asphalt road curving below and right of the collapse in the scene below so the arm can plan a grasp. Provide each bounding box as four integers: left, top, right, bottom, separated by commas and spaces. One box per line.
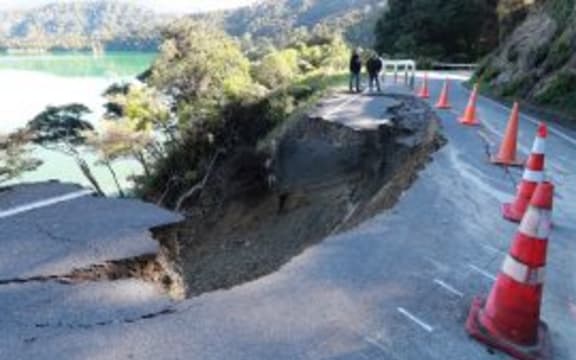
0, 77, 576, 360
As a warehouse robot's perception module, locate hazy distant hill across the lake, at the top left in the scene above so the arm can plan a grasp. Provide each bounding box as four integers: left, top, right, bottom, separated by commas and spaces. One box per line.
0, 0, 168, 50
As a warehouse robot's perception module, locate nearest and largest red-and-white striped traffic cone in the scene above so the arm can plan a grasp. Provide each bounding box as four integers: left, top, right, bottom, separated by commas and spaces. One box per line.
466, 182, 554, 360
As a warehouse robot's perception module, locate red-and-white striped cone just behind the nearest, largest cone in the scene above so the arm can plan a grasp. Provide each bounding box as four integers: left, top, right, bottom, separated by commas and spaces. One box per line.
502, 123, 548, 222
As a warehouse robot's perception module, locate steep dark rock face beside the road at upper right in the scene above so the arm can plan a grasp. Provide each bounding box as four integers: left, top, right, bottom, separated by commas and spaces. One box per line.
477, 0, 576, 115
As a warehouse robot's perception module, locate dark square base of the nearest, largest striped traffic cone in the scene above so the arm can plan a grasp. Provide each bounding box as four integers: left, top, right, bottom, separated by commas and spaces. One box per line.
466, 297, 552, 360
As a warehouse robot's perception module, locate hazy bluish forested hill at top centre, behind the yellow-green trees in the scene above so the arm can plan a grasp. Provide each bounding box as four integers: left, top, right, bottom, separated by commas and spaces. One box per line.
196, 0, 387, 45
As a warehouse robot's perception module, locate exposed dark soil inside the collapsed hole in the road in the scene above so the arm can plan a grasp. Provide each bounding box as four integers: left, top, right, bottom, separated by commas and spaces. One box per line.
152, 96, 442, 298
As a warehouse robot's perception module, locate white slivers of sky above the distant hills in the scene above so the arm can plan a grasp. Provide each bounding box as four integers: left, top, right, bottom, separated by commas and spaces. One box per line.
0, 0, 256, 13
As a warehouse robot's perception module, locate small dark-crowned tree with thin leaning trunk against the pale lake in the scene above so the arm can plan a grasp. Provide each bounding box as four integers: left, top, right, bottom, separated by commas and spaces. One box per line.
27, 104, 104, 196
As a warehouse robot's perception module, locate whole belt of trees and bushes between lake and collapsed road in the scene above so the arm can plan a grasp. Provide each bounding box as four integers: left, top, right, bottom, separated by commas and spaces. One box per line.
0, 19, 350, 200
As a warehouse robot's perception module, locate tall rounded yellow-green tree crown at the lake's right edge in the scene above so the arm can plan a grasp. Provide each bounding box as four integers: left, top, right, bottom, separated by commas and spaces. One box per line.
150, 19, 255, 115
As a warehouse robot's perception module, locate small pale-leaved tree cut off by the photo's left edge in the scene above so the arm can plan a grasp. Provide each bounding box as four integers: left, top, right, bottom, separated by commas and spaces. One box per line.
0, 130, 42, 184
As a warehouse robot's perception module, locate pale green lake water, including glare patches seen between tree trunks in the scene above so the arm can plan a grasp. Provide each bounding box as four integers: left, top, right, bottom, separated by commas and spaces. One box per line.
0, 53, 155, 194
